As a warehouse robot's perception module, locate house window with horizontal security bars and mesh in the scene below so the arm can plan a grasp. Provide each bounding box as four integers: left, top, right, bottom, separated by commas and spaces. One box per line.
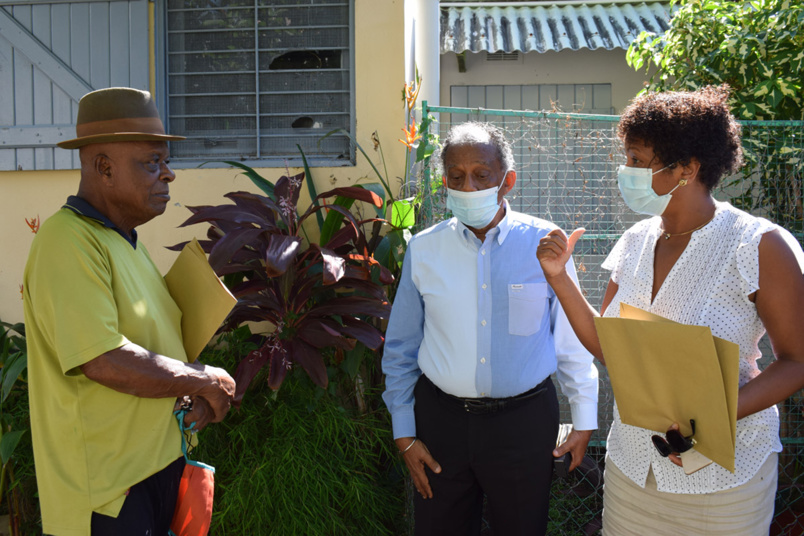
165, 0, 353, 166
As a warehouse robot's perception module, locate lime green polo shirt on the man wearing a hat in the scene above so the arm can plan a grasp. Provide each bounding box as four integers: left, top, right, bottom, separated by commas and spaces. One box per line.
24, 201, 187, 535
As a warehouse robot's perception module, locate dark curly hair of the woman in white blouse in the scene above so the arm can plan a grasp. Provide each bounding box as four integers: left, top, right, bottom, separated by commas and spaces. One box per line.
617, 84, 743, 192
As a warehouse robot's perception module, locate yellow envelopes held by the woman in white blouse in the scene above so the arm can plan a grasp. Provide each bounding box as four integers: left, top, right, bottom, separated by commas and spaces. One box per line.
595, 304, 740, 472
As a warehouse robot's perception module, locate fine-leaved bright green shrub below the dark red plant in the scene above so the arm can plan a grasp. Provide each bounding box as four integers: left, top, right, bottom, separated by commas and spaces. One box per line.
196, 336, 405, 536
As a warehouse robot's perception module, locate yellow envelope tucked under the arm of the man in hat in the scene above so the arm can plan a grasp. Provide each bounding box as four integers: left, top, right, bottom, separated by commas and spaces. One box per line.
165, 238, 237, 362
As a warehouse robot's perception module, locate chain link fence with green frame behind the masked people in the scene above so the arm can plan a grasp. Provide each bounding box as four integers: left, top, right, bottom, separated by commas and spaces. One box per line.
419, 103, 804, 536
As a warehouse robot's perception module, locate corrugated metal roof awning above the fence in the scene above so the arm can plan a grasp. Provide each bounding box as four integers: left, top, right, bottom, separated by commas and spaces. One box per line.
441, 3, 671, 54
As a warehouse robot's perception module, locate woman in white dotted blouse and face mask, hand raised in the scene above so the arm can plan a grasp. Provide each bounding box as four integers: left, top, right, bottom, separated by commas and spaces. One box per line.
537, 86, 804, 536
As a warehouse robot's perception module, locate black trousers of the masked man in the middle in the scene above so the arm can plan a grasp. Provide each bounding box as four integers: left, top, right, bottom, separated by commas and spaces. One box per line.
414, 377, 559, 536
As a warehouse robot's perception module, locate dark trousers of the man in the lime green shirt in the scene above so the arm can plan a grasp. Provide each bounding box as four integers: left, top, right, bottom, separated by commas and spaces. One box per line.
92, 456, 185, 536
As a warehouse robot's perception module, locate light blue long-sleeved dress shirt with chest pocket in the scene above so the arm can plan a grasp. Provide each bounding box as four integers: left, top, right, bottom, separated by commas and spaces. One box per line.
382, 201, 598, 438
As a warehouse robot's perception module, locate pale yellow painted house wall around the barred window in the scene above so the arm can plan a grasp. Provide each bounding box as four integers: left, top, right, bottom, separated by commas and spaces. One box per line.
0, 0, 405, 322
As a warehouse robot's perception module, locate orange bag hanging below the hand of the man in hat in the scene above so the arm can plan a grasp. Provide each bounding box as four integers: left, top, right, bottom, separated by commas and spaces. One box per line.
170, 409, 215, 536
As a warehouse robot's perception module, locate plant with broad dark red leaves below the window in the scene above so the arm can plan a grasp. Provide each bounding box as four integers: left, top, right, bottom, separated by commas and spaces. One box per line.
171, 168, 393, 401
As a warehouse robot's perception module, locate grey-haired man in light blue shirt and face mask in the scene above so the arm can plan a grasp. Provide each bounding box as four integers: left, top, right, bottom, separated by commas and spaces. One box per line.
383, 123, 597, 536
